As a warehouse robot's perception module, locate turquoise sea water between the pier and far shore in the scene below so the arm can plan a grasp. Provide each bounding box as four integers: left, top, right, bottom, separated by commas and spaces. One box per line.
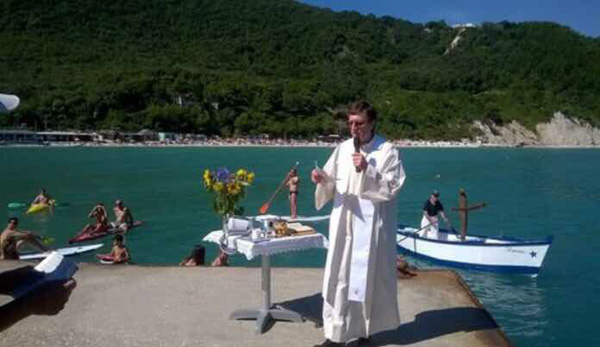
0, 147, 600, 346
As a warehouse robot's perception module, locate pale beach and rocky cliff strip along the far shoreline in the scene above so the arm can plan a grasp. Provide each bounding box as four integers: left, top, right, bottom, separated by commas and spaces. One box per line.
0, 112, 600, 148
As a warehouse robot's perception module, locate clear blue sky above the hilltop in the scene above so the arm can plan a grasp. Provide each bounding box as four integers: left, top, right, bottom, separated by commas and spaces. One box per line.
300, 0, 600, 37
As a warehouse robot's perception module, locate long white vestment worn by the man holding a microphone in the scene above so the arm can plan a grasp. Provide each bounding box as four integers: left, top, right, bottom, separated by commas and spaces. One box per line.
315, 136, 406, 342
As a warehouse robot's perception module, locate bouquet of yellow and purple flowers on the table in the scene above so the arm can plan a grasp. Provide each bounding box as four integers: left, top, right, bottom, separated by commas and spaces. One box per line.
204, 168, 254, 217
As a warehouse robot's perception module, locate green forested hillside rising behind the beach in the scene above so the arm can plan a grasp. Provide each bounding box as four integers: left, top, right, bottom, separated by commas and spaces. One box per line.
0, 0, 600, 139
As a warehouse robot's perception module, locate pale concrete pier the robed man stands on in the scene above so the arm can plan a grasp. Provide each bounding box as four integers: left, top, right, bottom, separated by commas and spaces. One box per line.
0, 261, 510, 347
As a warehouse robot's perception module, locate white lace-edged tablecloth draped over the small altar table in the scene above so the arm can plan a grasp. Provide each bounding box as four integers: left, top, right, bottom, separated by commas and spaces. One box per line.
202, 230, 329, 260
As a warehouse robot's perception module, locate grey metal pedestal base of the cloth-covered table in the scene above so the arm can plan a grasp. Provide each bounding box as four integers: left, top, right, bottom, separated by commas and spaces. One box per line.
229, 255, 304, 335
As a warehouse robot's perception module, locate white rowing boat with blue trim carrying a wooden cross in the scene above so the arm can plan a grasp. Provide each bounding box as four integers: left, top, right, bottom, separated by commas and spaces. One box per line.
396, 225, 553, 275
